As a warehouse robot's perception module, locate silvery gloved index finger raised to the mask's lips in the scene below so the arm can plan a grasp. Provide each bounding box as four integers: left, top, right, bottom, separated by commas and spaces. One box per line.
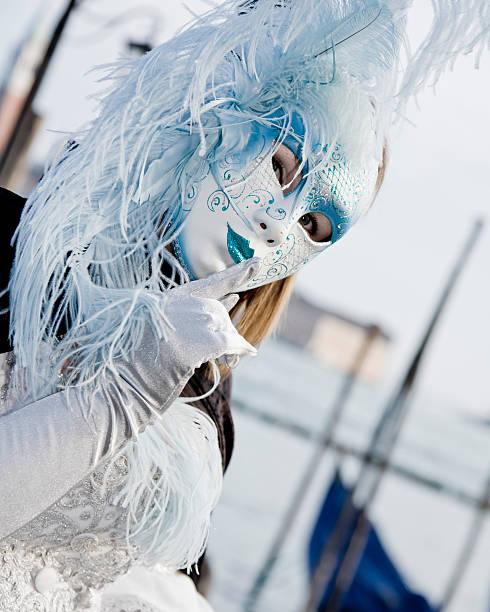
187, 257, 260, 300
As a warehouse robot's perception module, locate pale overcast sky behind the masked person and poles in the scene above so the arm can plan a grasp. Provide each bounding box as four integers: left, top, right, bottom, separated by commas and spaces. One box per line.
0, 0, 490, 414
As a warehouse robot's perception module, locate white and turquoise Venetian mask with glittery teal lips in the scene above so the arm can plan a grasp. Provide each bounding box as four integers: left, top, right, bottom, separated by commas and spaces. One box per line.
174, 123, 378, 290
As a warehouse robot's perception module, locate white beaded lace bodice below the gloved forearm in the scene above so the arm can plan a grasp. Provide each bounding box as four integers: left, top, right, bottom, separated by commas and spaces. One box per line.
0, 457, 135, 612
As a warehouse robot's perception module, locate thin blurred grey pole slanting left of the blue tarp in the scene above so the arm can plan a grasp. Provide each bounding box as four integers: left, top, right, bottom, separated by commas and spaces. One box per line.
244, 325, 380, 612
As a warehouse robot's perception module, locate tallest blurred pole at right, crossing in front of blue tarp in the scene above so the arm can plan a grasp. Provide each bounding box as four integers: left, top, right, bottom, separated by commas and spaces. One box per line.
304, 219, 483, 612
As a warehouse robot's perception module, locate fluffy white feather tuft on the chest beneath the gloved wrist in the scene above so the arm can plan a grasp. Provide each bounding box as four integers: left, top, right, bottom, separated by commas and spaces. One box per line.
114, 401, 223, 569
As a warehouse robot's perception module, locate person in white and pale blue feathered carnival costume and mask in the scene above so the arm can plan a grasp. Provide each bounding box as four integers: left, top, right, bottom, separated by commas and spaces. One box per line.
0, 0, 490, 612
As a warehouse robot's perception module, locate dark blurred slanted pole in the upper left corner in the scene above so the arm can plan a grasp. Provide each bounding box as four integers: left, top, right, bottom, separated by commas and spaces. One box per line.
0, 0, 80, 184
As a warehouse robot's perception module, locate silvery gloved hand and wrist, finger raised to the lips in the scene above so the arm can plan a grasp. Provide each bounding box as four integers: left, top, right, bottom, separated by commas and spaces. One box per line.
107, 259, 259, 430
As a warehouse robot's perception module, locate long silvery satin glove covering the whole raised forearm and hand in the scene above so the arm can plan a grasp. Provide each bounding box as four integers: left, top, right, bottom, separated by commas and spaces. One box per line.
0, 260, 257, 540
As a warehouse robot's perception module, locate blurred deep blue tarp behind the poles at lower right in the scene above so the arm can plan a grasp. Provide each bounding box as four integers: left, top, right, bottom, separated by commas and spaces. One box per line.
308, 474, 436, 612
